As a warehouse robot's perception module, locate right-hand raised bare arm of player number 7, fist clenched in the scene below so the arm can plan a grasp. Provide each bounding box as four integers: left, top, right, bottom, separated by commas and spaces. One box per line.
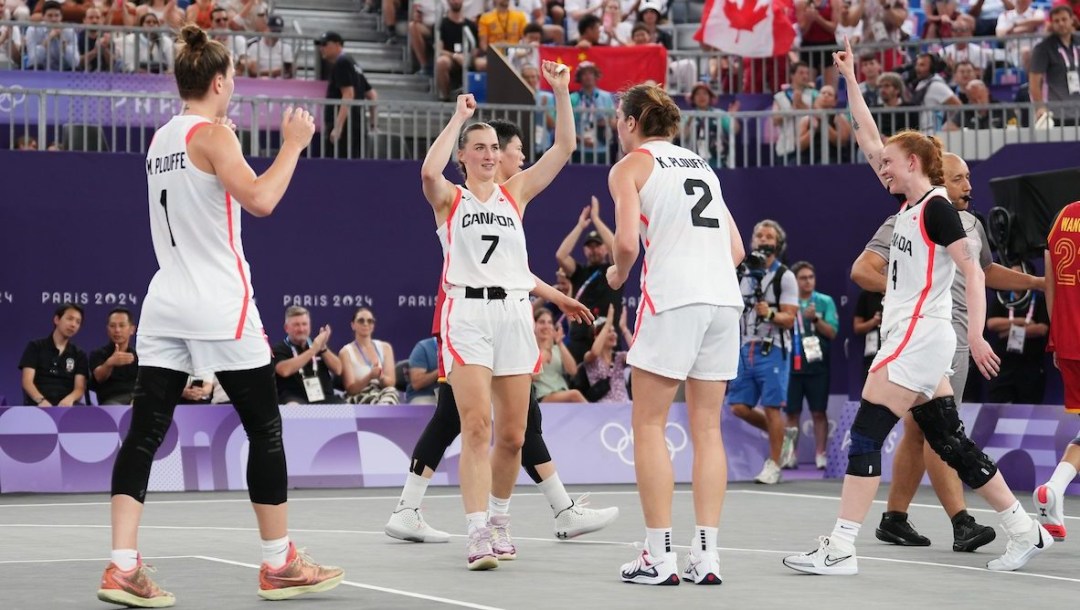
504, 60, 578, 209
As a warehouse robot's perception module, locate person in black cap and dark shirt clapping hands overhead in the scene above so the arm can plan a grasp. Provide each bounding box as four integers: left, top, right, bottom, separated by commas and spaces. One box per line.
555, 196, 623, 362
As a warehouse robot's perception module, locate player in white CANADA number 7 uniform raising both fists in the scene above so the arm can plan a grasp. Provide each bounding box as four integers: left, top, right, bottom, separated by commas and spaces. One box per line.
420, 62, 576, 570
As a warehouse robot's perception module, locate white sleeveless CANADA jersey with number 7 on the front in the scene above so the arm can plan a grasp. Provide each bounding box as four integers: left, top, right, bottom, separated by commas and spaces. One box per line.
437, 186, 536, 292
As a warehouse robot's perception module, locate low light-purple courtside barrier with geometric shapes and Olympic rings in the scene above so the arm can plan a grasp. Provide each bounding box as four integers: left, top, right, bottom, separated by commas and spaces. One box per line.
0, 401, 843, 492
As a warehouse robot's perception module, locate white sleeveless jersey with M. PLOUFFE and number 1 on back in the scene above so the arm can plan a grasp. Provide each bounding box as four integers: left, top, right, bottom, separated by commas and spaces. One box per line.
138, 116, 262, 340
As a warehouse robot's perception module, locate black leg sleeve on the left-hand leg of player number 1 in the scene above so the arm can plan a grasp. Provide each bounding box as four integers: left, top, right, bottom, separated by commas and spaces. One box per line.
112, 366, 188, 502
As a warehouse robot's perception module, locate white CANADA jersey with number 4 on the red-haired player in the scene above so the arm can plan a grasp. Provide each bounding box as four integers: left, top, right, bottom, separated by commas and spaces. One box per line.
881, 187, 956, 333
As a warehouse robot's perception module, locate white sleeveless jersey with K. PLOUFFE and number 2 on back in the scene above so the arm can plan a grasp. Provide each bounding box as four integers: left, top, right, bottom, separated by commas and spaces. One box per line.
638, 140, 743, 313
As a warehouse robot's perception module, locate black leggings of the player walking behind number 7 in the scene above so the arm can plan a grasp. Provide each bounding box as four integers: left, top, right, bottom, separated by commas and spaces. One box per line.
411, 383, 551, 483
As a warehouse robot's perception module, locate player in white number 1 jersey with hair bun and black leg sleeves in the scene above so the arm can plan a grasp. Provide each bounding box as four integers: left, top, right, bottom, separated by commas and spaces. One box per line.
97, 26, 343, 608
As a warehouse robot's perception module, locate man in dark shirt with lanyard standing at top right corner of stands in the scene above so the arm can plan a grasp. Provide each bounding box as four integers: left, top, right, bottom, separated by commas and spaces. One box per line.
1028, 6, 1080, 125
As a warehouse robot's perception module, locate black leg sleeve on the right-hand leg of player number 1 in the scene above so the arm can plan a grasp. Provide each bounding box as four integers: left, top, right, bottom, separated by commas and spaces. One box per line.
217, 364, 288, 505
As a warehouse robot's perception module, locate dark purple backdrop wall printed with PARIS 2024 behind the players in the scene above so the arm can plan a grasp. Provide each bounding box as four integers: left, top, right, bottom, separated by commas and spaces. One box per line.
0, 144, 1080, 404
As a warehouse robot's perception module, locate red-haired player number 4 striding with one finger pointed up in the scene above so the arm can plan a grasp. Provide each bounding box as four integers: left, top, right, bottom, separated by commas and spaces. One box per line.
784, 43, 1053, 574
